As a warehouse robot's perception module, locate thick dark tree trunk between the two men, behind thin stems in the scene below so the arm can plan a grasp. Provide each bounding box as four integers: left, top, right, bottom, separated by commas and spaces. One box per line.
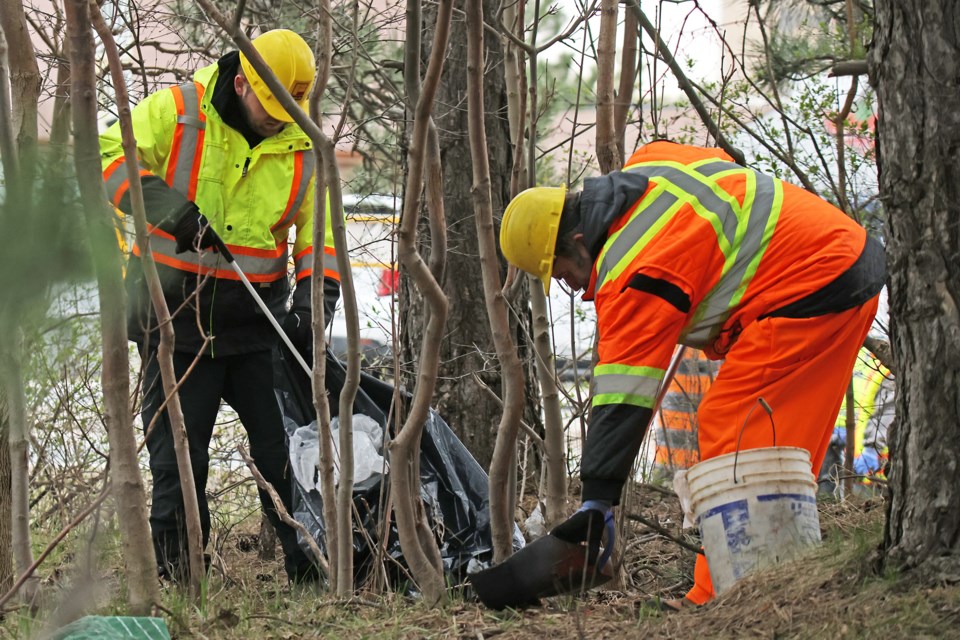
400, 0, 528, 468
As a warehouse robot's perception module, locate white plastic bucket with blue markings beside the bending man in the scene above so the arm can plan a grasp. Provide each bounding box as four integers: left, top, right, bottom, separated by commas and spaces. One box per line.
686, 447, 820, 594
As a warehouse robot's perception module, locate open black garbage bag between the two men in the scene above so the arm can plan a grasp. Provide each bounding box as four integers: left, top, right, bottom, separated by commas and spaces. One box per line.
276, 349, 524, 585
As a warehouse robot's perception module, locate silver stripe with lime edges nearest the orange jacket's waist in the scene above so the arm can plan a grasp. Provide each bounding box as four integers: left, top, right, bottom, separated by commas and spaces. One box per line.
681, 169, 783, 347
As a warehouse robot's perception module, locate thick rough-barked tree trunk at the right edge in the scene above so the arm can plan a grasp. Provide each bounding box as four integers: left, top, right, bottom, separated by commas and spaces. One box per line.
868, 0, 960, 583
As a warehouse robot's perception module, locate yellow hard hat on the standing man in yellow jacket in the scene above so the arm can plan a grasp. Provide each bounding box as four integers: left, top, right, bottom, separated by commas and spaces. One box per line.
240, 29, 317, 122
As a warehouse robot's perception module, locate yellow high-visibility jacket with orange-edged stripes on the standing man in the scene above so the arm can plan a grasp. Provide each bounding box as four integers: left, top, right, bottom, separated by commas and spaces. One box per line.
100, 54, 342, 355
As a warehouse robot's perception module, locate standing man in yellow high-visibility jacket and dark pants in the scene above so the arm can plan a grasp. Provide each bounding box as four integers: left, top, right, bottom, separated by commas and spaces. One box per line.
100, 29, 342, 582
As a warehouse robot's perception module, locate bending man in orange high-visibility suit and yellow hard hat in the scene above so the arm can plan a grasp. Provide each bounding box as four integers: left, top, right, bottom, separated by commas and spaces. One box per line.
500, 141, 886, 608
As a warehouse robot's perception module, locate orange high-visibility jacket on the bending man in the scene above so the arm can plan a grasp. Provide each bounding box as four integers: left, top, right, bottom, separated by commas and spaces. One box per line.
580, 142, 885, 503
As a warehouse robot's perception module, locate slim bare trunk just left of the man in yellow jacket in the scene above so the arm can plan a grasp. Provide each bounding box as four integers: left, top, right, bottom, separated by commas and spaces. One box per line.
65, 0, 161, 615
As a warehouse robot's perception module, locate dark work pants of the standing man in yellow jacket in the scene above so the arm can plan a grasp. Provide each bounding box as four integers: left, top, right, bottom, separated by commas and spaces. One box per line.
140, 350, 317, 582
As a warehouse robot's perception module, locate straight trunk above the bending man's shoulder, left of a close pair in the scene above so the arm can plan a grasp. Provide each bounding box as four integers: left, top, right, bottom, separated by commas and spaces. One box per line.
597, 0, 623, 173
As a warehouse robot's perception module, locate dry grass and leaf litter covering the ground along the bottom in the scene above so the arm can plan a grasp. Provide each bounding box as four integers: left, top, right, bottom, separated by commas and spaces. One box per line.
0, 488, 960, 640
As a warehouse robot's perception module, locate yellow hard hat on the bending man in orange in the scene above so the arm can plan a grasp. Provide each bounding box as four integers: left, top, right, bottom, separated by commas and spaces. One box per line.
500, 186, 567, 294
